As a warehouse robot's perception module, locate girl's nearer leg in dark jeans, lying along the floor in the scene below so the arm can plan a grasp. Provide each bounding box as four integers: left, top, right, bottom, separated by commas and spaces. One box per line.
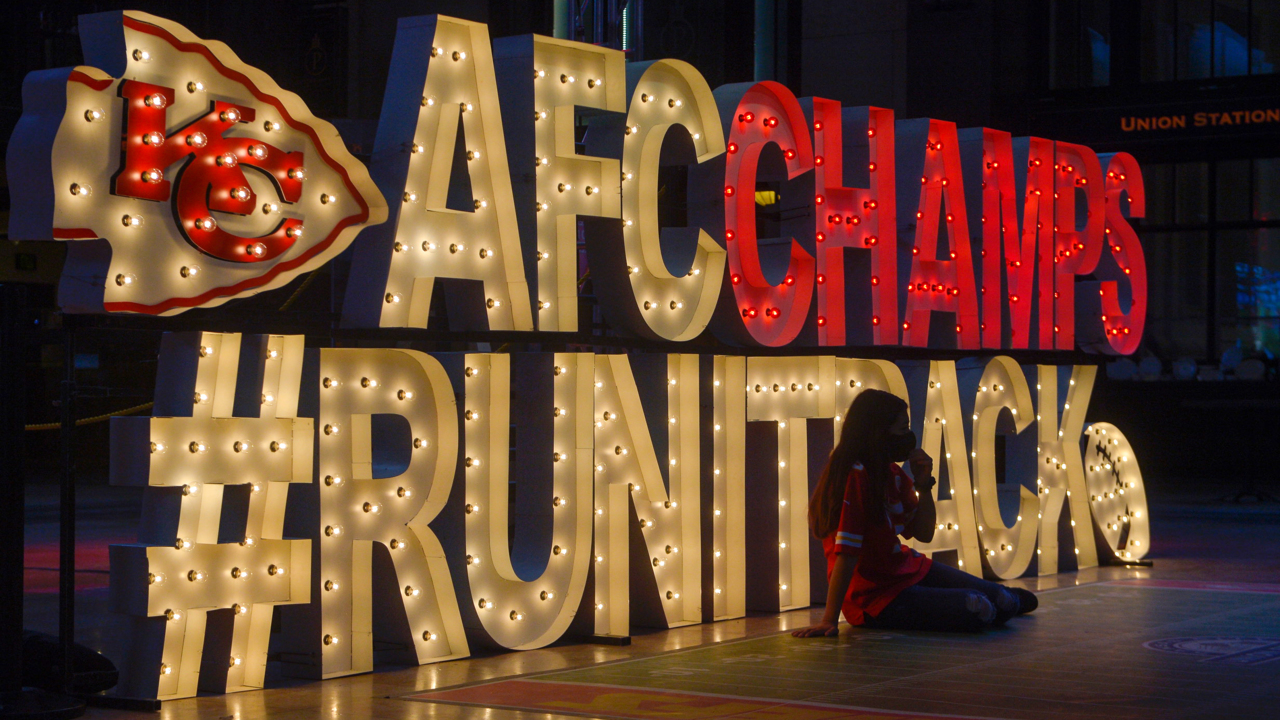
864, 584, 997, 633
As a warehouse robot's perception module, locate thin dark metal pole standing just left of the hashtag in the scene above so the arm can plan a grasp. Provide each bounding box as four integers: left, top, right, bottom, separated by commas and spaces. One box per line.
58, 315, 76, 692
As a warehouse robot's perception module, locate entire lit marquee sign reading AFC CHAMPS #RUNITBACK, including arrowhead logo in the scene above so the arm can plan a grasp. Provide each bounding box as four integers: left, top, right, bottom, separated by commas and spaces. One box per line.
0, 12, 1167, 698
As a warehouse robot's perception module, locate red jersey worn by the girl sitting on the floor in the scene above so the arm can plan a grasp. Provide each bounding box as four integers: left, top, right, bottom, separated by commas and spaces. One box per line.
822, 464, 933, 625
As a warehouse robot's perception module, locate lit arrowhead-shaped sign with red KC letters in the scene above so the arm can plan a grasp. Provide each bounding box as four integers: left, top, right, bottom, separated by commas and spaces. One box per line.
9, 12, 387, 315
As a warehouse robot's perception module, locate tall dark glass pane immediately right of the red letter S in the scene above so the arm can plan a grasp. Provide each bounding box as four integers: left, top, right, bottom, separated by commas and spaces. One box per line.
1142, 232, 1208, 359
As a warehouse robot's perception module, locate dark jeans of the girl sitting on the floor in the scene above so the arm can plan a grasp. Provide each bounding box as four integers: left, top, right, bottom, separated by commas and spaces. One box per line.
863, 562, 1018, 633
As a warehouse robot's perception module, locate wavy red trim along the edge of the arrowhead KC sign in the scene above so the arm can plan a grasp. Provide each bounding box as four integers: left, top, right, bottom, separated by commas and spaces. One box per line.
97, 15, 369, 315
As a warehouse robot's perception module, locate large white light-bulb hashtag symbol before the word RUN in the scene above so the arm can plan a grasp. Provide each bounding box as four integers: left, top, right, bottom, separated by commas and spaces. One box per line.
110, 333, 314, 700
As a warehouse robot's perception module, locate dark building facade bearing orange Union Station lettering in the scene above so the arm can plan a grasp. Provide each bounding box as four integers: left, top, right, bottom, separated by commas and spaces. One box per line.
800, 0, 1280, 369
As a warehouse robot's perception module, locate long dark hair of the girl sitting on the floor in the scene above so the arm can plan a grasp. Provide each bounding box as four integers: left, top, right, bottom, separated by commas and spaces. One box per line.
809, 388, 906, 538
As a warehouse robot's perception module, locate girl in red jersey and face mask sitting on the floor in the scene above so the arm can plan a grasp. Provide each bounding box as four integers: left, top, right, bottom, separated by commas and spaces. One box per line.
791, 389, 1037, 638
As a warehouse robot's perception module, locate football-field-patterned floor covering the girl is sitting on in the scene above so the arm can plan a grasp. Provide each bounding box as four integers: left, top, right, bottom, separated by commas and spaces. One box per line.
410, 579, 1280, 720
